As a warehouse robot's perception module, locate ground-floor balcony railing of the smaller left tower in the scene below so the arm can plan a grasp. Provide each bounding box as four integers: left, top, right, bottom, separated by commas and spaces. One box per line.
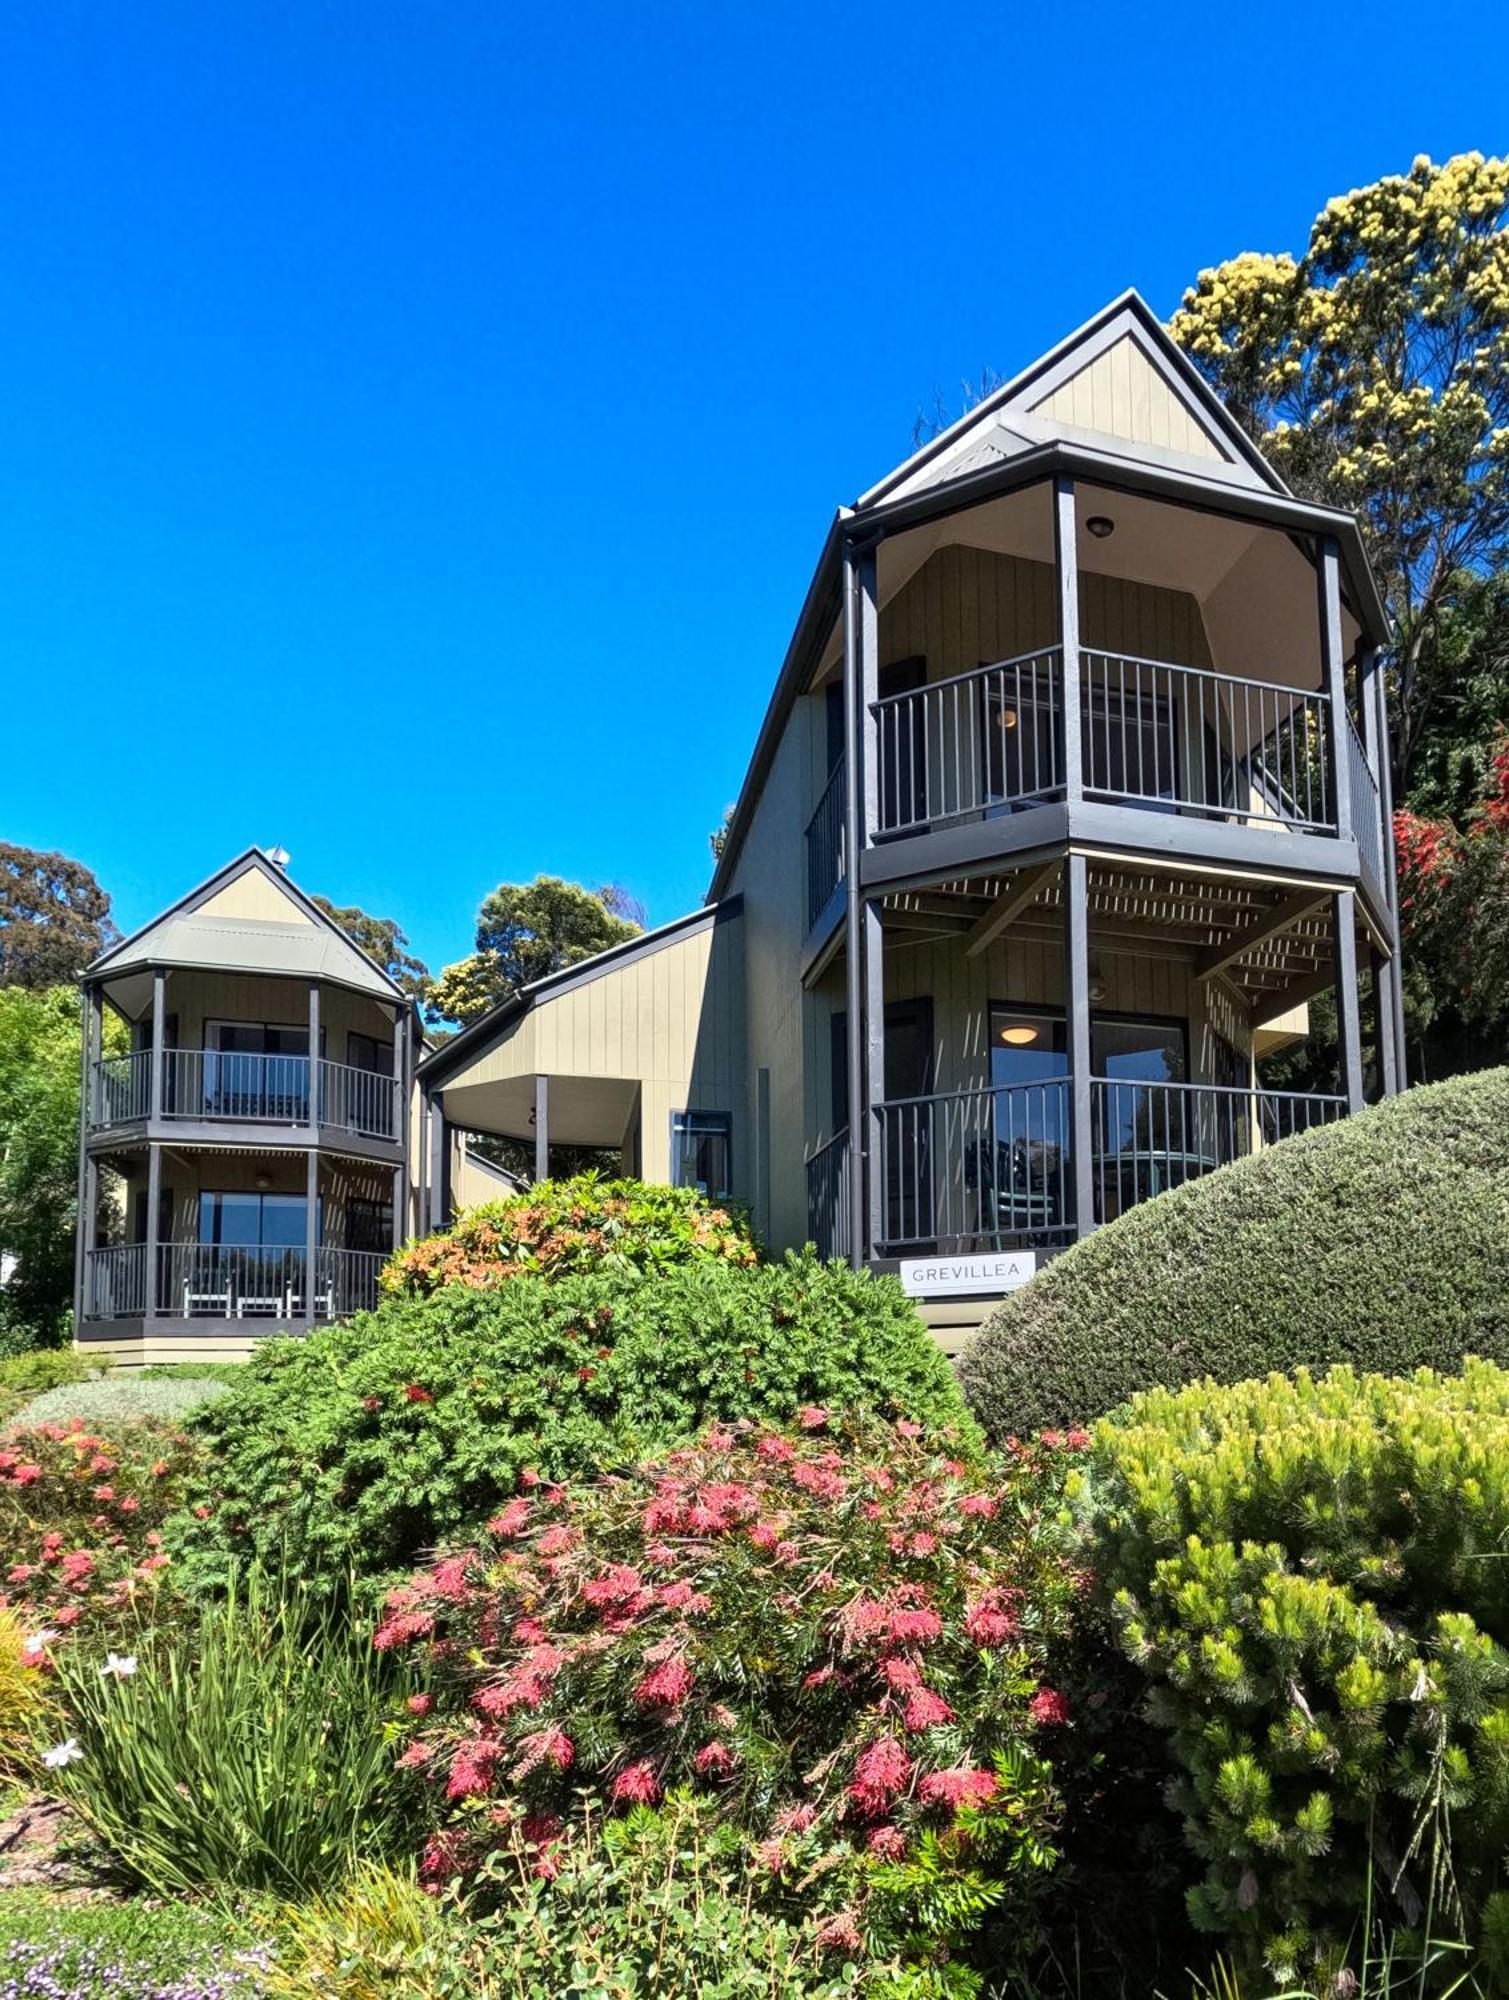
84, 1242, 386, 1324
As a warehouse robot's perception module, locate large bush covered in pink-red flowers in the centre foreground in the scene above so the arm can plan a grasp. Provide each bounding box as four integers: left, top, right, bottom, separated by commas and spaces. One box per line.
374, 1410, 1087, 1976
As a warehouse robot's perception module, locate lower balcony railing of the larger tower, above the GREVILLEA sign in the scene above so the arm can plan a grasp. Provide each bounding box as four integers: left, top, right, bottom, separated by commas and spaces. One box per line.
807, 1076, 1347, 1256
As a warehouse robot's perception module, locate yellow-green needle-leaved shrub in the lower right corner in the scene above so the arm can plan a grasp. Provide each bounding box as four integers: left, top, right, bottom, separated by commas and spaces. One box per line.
1081, 1360, 1509, 1990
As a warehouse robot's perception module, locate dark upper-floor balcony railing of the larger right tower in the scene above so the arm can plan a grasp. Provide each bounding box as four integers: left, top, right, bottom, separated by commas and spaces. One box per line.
873, 648, 1335, 834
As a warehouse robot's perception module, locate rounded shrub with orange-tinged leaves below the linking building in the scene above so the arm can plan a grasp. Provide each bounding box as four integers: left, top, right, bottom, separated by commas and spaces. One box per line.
380, 1174, 757, 1296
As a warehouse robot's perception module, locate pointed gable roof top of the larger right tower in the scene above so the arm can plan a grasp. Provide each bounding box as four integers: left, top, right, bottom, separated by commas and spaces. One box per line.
855, 292, 1289, 512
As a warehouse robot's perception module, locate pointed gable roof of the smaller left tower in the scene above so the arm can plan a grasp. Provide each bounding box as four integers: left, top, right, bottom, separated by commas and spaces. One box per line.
84, 848, 410, 1006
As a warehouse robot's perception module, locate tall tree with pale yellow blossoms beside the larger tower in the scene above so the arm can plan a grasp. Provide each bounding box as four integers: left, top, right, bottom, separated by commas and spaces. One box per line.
1171, 152, 1509, 794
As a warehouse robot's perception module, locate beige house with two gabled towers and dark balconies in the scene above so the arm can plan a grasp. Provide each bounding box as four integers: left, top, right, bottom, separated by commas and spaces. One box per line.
80, 294, 1403, 1342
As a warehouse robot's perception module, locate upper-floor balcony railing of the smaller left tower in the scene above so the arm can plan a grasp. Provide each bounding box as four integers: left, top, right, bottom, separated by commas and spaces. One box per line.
88, 1048, 402, 1144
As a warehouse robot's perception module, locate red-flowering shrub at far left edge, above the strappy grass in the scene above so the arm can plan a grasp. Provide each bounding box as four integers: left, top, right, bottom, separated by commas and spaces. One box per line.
0, 1418, 200, 1660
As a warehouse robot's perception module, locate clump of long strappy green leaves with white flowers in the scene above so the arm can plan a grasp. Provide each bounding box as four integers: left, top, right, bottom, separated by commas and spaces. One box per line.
50, 1570, 412, 1896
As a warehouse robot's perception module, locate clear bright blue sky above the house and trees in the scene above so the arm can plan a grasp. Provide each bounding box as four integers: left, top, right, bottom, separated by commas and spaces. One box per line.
0, 0, 1509, 966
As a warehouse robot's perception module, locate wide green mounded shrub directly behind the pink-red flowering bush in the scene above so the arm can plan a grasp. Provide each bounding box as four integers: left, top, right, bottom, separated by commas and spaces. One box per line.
167, 1256, 977, 1578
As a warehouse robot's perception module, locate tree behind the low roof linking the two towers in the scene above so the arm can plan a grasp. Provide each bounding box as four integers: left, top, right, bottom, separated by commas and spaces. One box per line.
434, 876, 644, 1026
